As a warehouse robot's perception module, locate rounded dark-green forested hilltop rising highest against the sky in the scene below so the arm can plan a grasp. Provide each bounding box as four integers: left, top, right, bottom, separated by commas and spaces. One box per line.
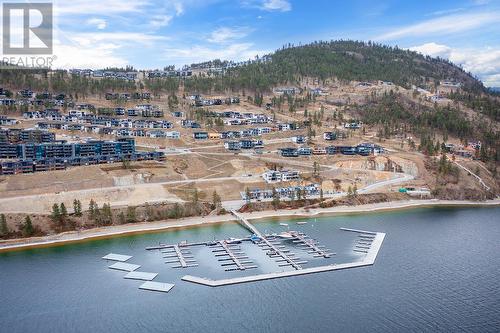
214, 41, 486, 93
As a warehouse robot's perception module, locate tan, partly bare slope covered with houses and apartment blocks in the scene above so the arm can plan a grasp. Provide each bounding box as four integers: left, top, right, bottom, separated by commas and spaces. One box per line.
0, 82, 497, 237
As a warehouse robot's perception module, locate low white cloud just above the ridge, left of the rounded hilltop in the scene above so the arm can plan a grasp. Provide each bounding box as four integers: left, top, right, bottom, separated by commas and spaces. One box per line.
163, 43, 269, 65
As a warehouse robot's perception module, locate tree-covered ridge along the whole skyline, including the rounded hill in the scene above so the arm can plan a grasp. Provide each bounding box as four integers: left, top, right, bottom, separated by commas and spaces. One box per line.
0, 40, 488, 95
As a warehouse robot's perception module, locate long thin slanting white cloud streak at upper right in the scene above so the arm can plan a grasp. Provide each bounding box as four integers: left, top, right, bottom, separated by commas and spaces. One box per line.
374, 12, 500, 41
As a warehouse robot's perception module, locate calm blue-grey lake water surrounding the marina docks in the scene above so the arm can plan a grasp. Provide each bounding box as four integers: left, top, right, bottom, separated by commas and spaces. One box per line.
0, 208, 500, 333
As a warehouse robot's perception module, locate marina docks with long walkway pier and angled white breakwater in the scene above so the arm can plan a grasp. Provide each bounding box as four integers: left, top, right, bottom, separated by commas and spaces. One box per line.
141, 210, 385, 287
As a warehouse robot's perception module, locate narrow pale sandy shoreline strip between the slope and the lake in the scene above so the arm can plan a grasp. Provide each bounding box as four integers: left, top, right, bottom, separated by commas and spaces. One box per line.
0, 199, 500, 253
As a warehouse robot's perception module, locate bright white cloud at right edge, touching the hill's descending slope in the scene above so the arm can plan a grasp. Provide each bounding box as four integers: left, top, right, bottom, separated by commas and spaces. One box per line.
410, 42, 500, 87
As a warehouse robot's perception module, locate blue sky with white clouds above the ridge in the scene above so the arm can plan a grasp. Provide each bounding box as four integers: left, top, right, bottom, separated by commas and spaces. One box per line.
1, 0, 500, 86
